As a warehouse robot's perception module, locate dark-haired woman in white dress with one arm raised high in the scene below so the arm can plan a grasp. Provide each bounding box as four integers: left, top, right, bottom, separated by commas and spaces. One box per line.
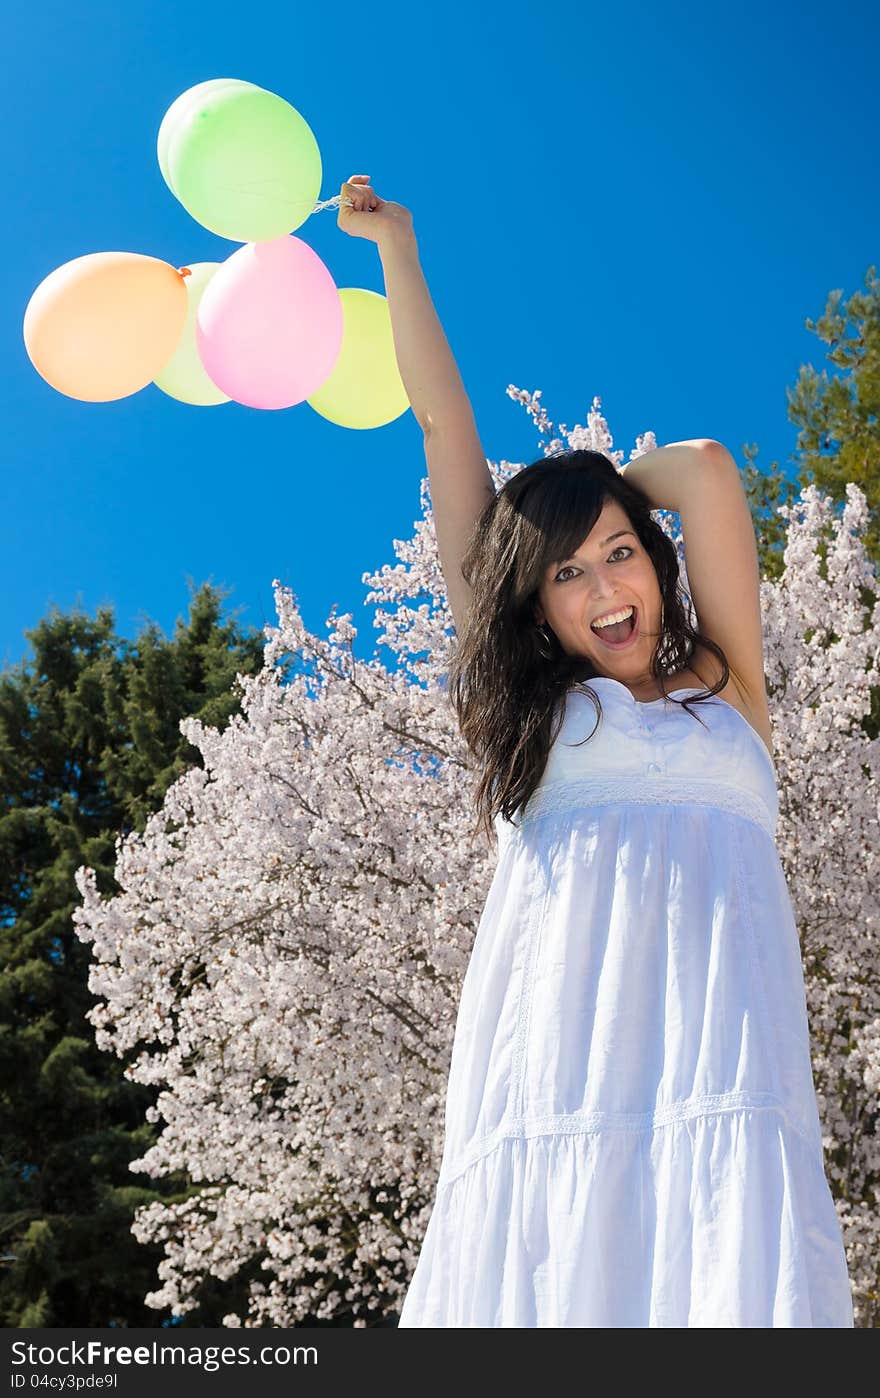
340, 176, 853, 1327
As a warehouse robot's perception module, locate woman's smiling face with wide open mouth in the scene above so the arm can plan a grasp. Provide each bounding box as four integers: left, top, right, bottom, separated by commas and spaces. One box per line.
536, 500, 662, 685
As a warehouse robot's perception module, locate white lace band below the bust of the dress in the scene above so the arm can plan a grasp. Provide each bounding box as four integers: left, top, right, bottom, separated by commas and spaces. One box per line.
499, 772, 776, 839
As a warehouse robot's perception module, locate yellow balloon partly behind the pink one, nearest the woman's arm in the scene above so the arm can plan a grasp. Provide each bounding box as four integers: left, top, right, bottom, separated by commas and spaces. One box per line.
308, 287, 410, 428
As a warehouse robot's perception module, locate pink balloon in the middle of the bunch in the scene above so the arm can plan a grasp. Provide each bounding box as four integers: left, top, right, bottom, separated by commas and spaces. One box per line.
196, 233, 343, 408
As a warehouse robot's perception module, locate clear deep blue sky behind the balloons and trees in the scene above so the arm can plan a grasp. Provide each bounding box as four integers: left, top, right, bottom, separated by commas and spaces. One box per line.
0, 0, 880, 676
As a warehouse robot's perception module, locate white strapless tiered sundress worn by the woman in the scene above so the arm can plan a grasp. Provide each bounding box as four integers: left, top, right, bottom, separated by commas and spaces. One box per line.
399, 677, 853, 1328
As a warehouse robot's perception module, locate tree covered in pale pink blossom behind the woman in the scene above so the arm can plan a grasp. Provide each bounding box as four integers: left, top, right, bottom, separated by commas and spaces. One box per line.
74, 386, 880, 1327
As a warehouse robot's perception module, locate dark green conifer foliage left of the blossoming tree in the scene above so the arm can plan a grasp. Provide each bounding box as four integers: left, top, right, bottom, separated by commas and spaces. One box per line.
0, 586, 264, 1327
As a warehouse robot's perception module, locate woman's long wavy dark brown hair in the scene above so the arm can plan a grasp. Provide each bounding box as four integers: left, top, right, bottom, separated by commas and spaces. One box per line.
449, 450, 730, 839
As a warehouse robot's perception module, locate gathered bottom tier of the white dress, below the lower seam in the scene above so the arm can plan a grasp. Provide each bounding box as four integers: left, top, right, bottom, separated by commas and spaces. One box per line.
400, 1107, 853, 1328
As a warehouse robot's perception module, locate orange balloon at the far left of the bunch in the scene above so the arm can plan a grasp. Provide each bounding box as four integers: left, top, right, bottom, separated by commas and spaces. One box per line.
24, 253, 189, 403
